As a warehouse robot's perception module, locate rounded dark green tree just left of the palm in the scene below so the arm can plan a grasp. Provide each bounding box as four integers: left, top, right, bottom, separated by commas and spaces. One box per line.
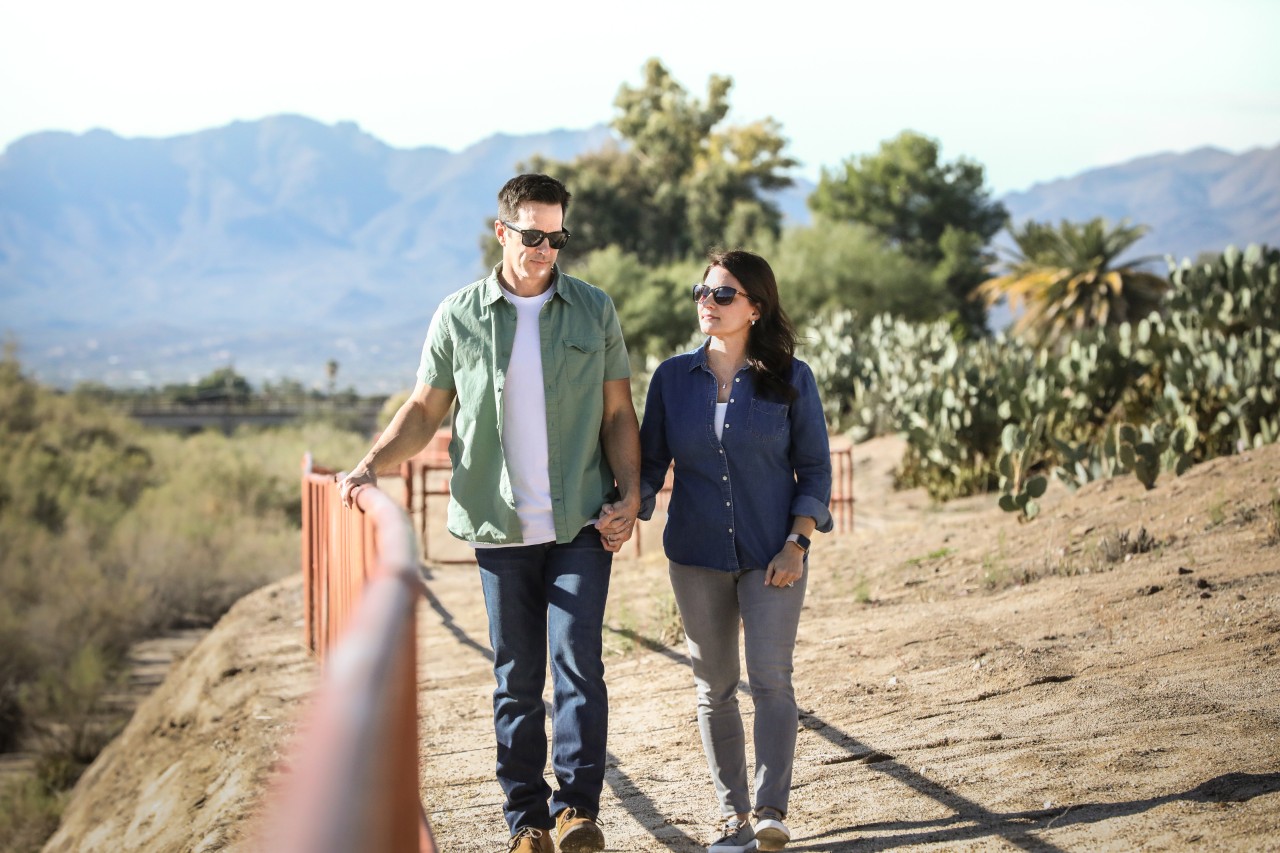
809, 131, 1009, 333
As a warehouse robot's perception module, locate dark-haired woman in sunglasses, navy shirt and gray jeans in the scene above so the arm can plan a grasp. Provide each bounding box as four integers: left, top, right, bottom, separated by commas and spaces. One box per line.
640, 251, 832, 853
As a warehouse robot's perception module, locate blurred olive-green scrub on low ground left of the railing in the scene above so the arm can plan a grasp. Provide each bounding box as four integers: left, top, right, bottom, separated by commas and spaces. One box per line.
0, 353, 367, 849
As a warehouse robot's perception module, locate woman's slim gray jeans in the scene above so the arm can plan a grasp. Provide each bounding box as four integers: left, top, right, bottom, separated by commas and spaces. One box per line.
669, 562, 809, 815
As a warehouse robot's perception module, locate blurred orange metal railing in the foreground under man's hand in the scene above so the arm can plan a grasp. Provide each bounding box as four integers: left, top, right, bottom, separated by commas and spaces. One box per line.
260, 455, 436, 853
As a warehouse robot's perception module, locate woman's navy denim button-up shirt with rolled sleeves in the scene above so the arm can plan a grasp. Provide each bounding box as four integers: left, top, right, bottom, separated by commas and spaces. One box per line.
640, 347, 832, 571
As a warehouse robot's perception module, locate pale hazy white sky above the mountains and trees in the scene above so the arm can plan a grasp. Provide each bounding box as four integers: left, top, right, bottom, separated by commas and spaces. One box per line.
0, 0, 1280, 193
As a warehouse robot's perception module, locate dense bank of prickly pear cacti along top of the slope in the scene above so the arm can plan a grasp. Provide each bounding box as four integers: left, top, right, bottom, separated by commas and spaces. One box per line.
803, 240, 1280, 504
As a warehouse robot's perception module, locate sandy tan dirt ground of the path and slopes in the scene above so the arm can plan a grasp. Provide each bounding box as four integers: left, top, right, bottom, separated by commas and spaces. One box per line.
46, 439, 1280, 853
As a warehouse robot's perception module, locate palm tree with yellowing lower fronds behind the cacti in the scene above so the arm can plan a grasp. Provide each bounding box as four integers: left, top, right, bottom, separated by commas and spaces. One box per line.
974, 218, 1169, 347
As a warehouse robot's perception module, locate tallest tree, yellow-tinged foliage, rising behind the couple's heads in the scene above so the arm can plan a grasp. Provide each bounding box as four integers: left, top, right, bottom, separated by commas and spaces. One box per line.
512, 59, 796, 264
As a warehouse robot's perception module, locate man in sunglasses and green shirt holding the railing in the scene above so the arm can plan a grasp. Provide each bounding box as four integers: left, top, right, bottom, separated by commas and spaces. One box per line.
340, 174, 640, 853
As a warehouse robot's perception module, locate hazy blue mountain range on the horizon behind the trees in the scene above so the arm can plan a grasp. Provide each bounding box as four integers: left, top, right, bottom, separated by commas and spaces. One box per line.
0, 115, 1280, 393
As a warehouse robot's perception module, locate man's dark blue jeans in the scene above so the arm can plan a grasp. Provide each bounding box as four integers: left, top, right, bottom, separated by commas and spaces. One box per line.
476, 526, 613, 834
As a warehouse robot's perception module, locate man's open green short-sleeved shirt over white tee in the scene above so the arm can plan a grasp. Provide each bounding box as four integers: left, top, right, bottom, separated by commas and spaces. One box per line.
417, 266, 631, 544
